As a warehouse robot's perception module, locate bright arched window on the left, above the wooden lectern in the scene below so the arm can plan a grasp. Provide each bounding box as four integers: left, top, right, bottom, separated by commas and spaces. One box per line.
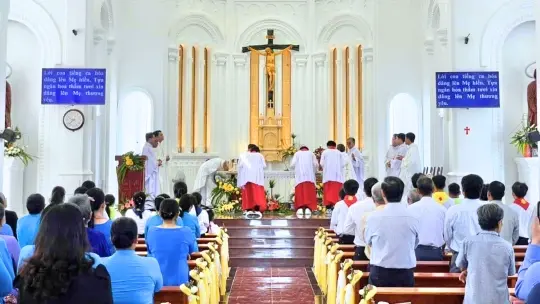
117, 91, 153, 154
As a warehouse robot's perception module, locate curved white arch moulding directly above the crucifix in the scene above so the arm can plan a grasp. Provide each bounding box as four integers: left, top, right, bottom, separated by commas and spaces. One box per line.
236, 19, 306, 51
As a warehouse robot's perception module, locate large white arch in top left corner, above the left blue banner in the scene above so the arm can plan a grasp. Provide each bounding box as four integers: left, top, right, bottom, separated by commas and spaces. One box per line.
8, 0, 62, 66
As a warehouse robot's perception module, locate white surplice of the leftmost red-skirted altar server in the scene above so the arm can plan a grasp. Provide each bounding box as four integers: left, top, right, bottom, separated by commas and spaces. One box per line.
237, 152, 266, 188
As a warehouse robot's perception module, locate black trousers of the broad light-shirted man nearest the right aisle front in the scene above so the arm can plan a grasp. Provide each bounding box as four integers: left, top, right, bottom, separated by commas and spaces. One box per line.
369, 265, 414, 287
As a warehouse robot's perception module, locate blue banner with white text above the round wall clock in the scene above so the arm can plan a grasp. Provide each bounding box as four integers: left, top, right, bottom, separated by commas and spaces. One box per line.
41, 68, 107, 105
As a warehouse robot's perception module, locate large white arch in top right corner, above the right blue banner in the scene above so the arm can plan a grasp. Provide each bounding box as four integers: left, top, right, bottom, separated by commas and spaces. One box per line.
480, 0, 536, 69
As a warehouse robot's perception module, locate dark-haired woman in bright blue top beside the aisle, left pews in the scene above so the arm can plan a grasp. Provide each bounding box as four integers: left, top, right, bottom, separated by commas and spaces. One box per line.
146, 199, 198, 286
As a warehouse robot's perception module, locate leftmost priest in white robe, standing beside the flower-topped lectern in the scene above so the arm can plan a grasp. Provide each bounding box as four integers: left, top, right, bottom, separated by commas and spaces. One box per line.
142, 132, 159, 199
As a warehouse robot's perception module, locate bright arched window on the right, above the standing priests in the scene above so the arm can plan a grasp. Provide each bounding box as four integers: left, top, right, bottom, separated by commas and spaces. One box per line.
390, 93, 420, 138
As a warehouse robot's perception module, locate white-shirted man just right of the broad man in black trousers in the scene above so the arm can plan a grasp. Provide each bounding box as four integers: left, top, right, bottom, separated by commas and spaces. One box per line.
409, 176, 446, 261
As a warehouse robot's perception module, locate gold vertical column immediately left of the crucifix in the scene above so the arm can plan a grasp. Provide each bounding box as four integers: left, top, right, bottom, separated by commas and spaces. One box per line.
249, 52, 259, 145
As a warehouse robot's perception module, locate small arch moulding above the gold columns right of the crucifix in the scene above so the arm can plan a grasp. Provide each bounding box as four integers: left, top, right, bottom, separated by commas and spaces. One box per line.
317, 14, 373, 45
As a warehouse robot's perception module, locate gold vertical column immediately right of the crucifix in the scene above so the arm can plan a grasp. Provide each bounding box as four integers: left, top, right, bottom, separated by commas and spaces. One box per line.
280, 50, 292, 148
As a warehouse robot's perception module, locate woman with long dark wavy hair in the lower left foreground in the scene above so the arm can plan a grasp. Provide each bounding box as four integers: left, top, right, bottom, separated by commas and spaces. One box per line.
15, 204, 113, 304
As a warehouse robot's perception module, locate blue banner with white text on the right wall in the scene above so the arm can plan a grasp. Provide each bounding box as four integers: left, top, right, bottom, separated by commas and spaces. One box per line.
435, 72, 501, 108
